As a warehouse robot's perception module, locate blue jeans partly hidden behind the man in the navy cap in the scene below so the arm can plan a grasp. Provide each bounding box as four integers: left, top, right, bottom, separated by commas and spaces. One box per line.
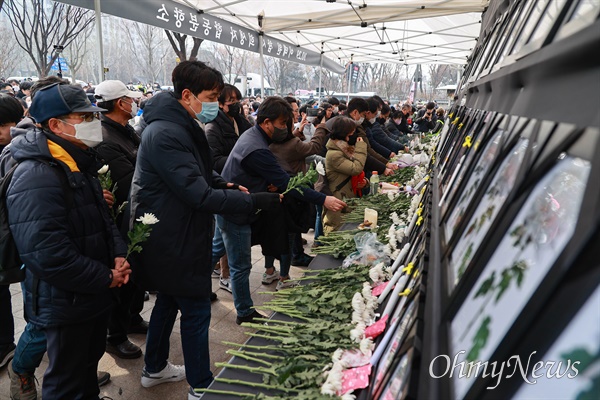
13, 322, 46, 374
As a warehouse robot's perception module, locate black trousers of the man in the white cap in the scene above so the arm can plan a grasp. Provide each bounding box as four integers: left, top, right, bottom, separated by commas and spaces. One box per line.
106, 281, 145, 345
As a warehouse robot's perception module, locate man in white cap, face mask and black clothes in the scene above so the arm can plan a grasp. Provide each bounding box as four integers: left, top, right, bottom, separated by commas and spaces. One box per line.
94, 80, 148, 359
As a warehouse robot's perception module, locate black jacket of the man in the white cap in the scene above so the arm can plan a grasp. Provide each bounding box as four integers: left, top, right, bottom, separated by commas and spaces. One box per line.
95, 115, 140, 226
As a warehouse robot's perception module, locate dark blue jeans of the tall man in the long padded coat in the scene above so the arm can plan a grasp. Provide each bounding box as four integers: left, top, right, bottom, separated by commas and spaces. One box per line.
144, 293, 213, 388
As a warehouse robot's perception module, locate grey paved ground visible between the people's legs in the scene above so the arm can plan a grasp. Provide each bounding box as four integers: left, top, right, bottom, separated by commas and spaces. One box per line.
0, 230, 313, 400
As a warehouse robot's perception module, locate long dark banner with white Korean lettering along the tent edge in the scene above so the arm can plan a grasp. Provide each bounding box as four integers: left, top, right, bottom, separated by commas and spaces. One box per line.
58, 0, 344, 74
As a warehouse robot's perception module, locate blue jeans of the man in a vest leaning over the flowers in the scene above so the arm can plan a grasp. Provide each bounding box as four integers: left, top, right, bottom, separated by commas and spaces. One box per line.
213, 215, 254, 317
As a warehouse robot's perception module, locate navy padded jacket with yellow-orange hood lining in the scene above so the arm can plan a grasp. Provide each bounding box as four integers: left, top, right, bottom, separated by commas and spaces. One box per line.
7, 129, 127, 326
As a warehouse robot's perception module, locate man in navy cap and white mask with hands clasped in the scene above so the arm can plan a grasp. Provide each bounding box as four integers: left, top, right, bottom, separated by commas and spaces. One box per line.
7, 84, 131, 399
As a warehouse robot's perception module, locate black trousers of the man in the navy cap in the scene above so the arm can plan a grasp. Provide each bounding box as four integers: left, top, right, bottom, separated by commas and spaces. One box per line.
42, 311, 109, 400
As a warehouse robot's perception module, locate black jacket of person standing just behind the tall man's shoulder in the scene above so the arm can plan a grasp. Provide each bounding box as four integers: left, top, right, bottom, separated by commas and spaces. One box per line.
206, 110, 252, 173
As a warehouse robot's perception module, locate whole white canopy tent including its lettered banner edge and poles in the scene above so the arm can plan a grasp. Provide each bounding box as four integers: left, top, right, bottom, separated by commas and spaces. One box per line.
57, 0, 489, 93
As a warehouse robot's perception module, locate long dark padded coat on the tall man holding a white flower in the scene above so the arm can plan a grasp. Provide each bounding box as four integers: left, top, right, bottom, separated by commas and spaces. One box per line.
130, 92, 253, 298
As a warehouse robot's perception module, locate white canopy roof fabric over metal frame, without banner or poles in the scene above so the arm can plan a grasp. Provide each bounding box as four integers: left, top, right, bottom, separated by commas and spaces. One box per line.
175, 0, 489, 65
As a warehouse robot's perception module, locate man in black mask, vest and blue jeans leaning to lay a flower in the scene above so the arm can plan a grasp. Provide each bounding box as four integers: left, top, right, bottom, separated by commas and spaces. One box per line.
213, 96, 346, 325
